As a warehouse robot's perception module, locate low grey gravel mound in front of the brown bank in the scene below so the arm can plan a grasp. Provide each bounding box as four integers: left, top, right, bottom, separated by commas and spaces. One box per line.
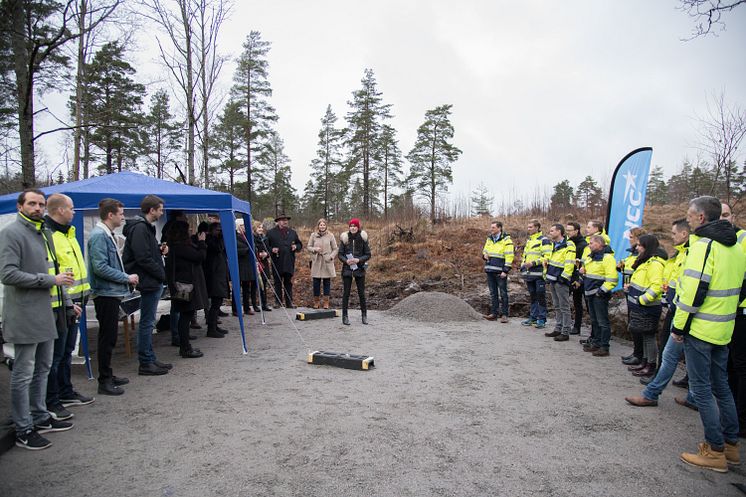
386, 292, 482, 323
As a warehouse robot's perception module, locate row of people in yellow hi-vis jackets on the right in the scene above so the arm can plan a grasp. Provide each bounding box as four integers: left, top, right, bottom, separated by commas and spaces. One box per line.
482, 197, 746, 472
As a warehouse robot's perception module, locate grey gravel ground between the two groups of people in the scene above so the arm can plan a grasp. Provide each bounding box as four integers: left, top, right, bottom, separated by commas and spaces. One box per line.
0, 298, 746, 497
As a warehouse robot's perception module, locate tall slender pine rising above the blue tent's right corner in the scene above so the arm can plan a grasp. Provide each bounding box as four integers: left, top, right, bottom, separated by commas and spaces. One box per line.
231, 31, 277, 202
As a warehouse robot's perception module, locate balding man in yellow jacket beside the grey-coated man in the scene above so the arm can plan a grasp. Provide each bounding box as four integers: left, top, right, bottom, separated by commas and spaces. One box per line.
44, 193, 94, 420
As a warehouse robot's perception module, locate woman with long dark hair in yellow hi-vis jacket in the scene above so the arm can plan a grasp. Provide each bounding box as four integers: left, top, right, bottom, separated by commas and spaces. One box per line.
624, 235, 668, 378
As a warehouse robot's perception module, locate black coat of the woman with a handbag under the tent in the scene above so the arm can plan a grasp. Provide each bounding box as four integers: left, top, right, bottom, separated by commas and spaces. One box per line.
166, 241, 207, 311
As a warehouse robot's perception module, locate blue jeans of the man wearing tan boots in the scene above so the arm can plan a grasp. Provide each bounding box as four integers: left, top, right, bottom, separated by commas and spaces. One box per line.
684, 335, 738, 449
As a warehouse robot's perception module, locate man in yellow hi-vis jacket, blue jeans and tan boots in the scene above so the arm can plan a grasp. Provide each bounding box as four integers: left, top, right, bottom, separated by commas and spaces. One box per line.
671, 196, 746, 473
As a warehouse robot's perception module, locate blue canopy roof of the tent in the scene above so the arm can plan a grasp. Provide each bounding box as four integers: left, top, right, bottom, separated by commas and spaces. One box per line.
0, 171, 250, 214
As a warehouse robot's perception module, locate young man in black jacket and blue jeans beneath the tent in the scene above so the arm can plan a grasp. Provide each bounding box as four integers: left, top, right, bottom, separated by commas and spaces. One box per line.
122, 195, 171, 376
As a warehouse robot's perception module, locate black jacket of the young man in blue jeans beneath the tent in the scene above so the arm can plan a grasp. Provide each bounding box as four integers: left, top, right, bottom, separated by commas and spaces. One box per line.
122, 216, 166, 292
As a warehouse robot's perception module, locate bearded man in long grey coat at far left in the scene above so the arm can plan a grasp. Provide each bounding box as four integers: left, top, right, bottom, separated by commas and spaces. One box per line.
0, 190, 73, 450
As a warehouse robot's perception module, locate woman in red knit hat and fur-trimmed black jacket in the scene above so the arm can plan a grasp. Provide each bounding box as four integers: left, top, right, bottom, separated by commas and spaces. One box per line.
337, 218, 370, 325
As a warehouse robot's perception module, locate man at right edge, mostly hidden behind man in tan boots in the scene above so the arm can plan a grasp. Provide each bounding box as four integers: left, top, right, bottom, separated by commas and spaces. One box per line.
720, 203, 746, 438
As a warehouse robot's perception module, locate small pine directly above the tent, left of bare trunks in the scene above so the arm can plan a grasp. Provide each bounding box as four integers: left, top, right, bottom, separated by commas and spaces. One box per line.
143, 89, 182, 179
